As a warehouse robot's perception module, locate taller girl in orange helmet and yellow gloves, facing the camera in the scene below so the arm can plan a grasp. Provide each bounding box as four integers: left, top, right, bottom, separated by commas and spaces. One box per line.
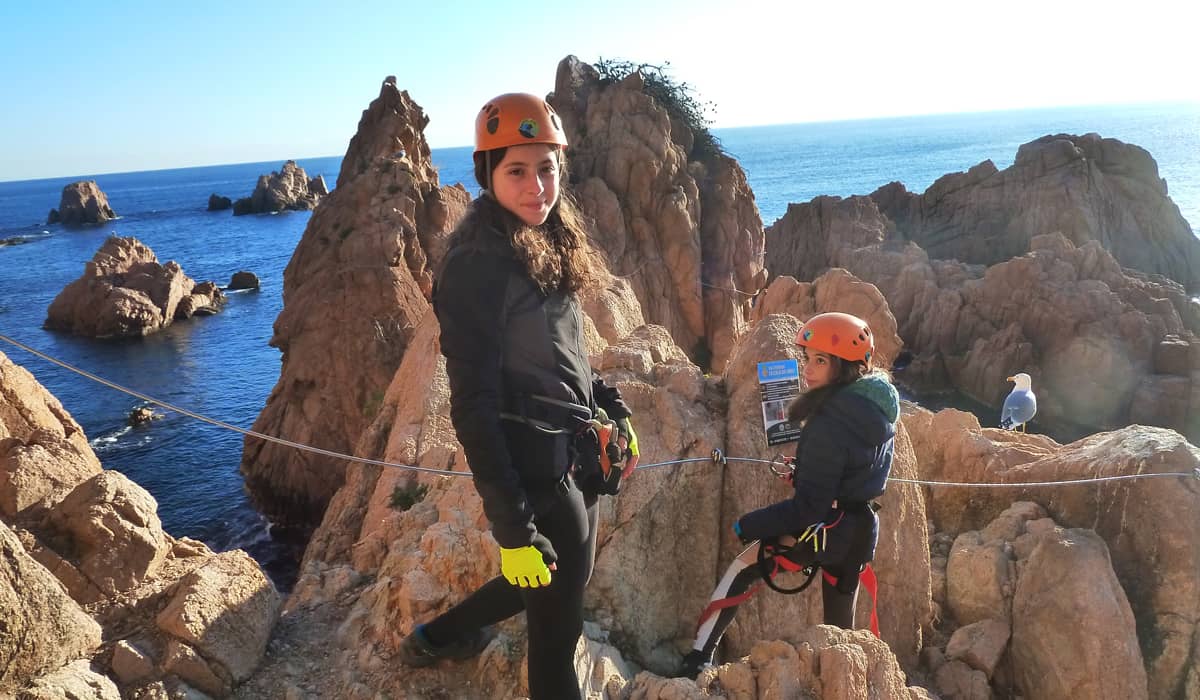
400, 94, 637, 700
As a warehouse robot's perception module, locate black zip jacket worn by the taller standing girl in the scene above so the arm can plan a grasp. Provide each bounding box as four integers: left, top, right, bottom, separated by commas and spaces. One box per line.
433, 207, 630, 549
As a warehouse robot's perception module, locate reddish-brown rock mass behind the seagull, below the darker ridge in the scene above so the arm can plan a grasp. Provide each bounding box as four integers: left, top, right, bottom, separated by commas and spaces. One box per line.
767, 186, 1200, 439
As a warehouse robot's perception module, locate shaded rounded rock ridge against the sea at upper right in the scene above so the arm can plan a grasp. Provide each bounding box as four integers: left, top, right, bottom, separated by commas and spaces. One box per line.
871, 133, 1200, 291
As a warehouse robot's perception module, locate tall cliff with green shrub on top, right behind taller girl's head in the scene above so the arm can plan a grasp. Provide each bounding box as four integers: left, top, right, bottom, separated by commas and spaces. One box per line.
550, 56, 767, 371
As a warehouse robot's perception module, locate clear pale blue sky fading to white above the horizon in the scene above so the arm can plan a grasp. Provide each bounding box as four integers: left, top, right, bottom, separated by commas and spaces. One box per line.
0, 0, 1200, 180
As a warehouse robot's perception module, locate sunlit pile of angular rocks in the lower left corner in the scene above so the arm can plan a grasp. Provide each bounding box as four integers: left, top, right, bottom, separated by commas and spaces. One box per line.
0, 353, 280, 700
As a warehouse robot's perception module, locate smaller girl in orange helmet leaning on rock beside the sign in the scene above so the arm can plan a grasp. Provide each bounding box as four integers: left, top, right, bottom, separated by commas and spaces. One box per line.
678, 313, 900, 678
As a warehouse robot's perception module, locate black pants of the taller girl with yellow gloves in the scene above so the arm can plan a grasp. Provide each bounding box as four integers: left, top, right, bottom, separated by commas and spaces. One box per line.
425, 479, 596, 700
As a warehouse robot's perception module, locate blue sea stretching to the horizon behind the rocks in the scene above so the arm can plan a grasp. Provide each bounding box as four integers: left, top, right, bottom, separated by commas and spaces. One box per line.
0, 104, 1200, 590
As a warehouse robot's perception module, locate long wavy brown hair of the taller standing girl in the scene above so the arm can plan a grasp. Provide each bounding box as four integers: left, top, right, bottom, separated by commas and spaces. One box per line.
460, 148, 602, 293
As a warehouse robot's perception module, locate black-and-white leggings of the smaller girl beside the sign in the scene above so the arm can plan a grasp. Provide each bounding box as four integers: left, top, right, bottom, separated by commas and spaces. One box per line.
692, 543, 863, 660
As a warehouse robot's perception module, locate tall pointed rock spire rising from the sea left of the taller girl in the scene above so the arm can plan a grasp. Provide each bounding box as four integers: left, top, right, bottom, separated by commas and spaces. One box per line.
241, 80, 468, 528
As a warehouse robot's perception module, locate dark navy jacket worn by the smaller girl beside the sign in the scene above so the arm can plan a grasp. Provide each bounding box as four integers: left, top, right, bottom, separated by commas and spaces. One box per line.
738, 375, 900, 549
